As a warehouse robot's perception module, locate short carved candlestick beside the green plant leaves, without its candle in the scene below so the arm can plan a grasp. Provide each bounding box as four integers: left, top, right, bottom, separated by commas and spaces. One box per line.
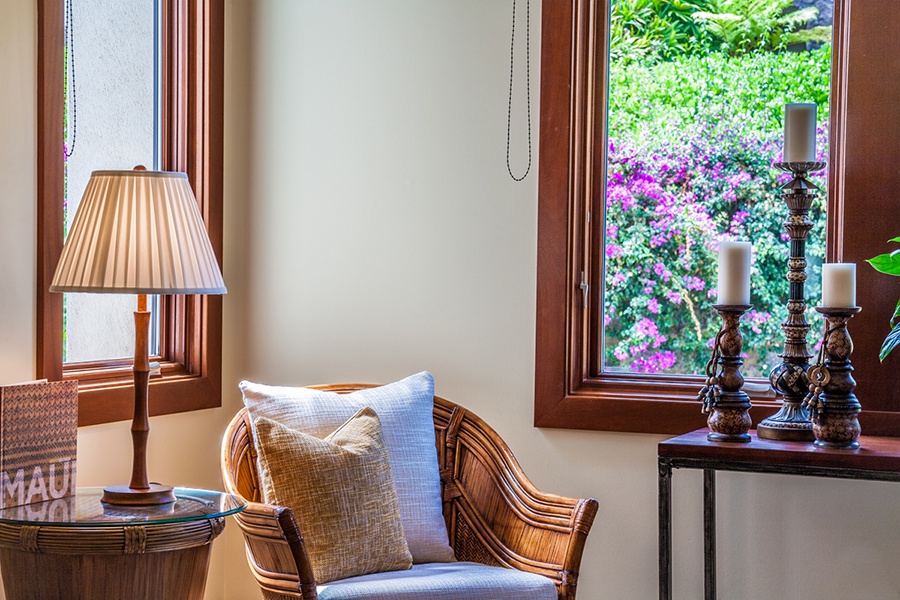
812, 306, 862, 448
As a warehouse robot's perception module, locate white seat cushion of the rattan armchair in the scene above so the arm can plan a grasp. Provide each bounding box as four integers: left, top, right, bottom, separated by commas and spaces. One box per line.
317, 562, 557, 600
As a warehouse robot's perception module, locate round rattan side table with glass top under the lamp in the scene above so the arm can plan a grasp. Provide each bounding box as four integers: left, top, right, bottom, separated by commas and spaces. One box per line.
0, 488, 246, 600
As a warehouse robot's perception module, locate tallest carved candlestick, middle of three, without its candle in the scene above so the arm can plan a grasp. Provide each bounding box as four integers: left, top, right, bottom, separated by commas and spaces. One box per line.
756, 162, 825, 442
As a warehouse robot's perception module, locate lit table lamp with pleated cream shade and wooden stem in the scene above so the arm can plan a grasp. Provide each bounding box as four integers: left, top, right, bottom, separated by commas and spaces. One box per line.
50, 167, 226, 505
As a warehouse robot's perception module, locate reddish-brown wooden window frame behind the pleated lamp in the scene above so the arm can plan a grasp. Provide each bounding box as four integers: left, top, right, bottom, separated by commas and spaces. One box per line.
36, 0, 225, 426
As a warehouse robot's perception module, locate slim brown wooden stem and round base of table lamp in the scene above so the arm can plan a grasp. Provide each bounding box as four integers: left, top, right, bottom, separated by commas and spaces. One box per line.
102, 294, 175, 505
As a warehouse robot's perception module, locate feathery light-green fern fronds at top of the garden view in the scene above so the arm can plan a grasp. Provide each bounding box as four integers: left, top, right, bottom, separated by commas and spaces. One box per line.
693, 0, 831, 56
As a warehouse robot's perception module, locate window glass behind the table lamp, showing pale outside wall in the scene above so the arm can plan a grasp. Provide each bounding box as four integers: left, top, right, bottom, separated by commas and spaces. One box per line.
63, 0, 159, 363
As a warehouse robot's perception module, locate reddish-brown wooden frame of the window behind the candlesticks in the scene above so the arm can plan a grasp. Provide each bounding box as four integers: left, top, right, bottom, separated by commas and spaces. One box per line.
534, 0, 900, 435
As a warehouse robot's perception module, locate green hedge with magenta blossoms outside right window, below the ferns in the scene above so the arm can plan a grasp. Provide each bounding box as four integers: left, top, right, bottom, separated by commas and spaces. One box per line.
604, 47, 830, 375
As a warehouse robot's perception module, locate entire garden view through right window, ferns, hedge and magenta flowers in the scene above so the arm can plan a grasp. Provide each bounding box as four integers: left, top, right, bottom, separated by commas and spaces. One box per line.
601, 0, 833, 377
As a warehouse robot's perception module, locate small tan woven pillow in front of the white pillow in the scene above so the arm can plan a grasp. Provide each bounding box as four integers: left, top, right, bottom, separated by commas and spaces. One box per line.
255, 408, 412, 583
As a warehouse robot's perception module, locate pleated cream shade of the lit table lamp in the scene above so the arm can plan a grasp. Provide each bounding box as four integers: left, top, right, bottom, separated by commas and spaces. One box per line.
50, 171, 226, 294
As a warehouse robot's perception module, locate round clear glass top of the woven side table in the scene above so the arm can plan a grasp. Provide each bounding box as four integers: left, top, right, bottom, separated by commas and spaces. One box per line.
0, 487, 247, 527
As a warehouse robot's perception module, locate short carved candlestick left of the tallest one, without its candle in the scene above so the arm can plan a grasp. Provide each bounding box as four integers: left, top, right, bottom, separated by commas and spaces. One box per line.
699, 304, 751, 442
